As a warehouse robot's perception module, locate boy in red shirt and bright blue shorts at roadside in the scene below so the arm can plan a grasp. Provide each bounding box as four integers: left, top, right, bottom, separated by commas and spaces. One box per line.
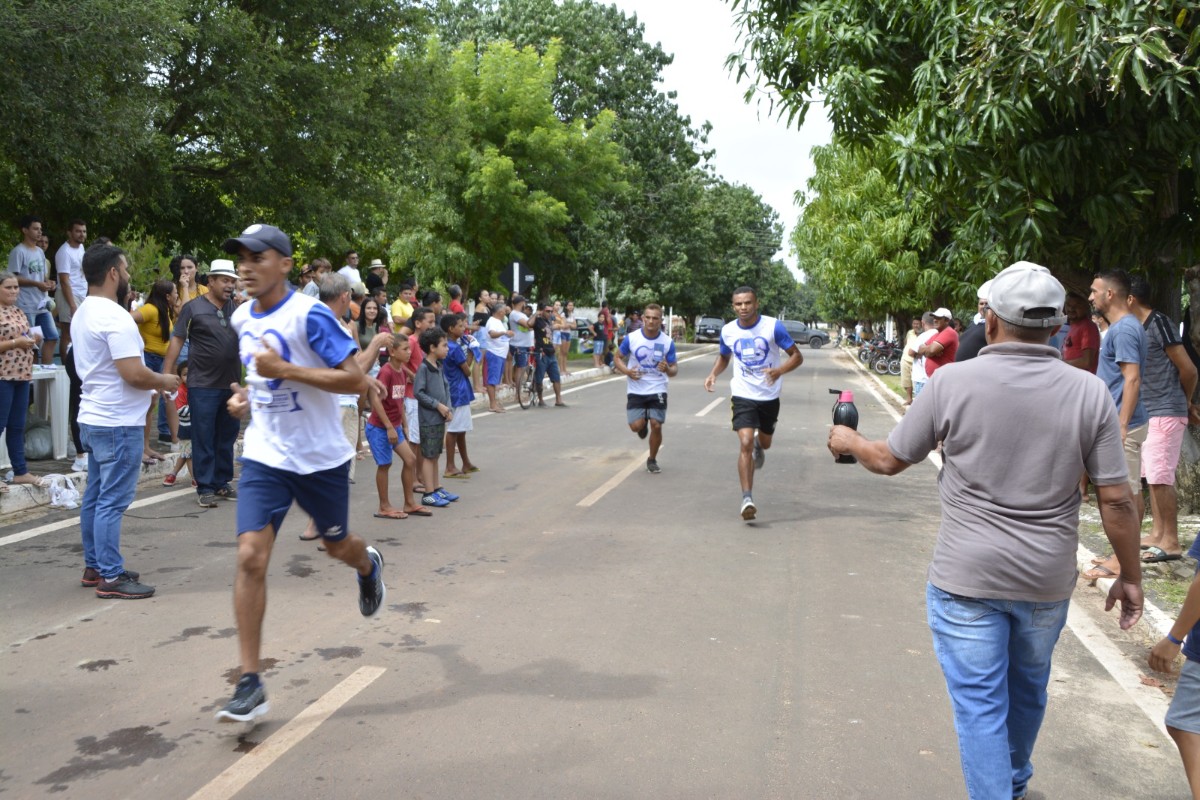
365, 336, 433, 519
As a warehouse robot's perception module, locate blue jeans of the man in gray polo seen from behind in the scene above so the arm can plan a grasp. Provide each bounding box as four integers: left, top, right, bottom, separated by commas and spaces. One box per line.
925, 584, 1070, 800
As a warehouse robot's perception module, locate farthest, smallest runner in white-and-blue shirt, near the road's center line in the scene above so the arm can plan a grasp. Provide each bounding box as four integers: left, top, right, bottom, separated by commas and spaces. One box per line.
613, 302, 679, 475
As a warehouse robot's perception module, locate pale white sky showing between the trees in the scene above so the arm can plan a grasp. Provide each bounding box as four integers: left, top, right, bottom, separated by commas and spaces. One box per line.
604, 0, 833, 278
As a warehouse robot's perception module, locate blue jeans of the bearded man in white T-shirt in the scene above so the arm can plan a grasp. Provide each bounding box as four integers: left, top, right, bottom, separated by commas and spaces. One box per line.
79, 422, 145, 581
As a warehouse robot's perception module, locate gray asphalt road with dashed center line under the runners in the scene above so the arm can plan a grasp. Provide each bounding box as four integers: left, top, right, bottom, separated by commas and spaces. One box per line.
0, 349, 1189, 800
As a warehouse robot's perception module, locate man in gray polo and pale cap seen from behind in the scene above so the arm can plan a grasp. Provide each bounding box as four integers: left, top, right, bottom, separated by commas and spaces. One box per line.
829, 261, 1142, 798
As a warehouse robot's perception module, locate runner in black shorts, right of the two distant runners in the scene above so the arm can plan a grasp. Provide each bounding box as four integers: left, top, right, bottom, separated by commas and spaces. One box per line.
704, 287, 804, 519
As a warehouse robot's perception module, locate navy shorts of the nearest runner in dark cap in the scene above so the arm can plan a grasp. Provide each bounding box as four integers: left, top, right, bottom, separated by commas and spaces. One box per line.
238, 458, 350, 542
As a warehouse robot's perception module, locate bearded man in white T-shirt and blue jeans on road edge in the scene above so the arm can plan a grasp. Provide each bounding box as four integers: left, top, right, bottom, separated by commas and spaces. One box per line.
72, 245, 179, 600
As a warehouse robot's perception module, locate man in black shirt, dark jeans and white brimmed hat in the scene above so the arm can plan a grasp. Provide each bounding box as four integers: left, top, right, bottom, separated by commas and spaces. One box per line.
162, 259, 241, 509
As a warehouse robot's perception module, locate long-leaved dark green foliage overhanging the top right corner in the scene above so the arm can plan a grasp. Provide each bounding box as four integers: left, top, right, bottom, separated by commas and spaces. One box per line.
731, 0, 1200, 319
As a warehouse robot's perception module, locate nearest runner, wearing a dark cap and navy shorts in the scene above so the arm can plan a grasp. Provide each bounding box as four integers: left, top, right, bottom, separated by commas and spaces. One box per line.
217, 224, 385, 722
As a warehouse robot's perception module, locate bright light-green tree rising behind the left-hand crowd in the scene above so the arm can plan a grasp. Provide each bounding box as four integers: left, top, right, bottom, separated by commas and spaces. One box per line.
395, 40, 624, 291
